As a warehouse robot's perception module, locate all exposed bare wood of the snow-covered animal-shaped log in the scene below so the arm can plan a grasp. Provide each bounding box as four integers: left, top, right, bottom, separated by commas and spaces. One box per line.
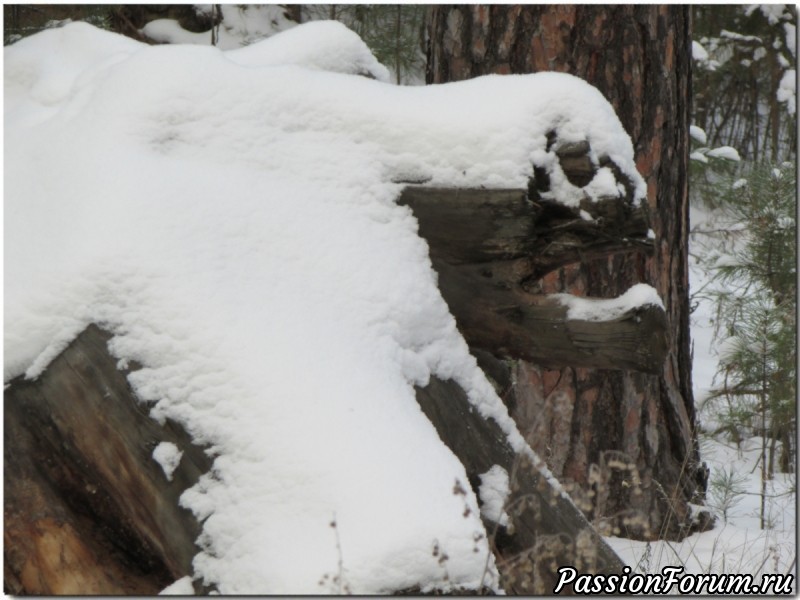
4, 179, 666, 595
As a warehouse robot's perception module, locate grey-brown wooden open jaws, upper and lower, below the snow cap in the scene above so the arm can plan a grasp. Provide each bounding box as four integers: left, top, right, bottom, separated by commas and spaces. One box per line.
399, 187, 666, 373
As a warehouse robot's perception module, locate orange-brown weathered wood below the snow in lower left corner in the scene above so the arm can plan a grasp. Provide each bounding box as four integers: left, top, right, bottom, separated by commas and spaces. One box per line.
3, 326, 211, 595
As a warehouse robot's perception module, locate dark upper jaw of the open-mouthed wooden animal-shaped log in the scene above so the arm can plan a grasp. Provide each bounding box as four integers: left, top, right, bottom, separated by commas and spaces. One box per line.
398, 186, 653, 280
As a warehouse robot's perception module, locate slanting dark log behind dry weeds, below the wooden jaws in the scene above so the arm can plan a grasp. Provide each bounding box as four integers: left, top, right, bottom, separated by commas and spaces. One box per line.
416, 377, 624, 595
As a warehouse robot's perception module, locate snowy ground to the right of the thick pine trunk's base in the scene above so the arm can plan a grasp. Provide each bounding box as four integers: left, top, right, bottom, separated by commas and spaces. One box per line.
606, 200, 797, 590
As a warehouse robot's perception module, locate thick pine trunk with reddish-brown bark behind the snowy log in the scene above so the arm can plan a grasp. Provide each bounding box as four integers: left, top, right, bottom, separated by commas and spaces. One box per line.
427, 5, 707, 539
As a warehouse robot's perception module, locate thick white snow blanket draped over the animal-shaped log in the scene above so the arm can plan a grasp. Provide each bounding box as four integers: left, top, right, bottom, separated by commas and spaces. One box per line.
4, 23, 644, 594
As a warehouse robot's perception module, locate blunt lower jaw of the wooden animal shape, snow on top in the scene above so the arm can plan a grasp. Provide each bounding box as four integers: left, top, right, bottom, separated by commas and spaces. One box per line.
433, 260, 667, 374
